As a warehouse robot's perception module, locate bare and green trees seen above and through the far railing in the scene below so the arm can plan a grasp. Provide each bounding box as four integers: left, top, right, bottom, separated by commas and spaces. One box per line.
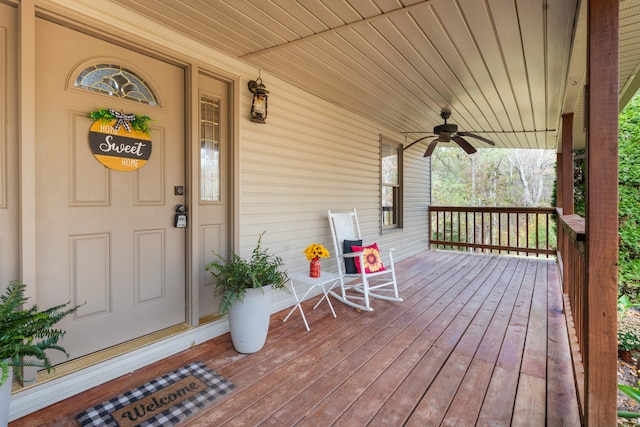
431, 147, 556, 252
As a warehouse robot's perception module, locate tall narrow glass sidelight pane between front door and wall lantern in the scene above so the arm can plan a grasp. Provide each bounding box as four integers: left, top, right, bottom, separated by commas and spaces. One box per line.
200, 96, 220, 202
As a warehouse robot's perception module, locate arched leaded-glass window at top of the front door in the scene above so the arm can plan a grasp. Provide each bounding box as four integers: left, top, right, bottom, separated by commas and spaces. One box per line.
73, 64, 160, 107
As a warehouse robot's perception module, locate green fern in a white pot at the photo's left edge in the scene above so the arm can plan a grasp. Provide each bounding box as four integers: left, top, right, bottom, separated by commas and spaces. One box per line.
0, 280, 78, 425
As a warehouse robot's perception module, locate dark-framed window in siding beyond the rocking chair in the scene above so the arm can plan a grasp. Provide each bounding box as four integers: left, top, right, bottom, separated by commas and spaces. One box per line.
380, 136, 402, 229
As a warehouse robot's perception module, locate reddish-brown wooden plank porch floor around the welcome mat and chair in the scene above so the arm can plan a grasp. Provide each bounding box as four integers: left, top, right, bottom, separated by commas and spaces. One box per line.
10, 251, 580, 427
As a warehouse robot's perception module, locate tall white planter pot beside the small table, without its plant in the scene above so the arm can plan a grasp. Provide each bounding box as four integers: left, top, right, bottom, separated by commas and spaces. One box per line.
229, 285, 271, 353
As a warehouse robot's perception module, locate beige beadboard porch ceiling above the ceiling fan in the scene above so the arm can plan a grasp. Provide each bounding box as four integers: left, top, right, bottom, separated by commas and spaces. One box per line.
109, 0, 640, 149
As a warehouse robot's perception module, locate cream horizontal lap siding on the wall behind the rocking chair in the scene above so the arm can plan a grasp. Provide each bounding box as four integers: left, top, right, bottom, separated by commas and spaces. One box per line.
239, 75, 430, 290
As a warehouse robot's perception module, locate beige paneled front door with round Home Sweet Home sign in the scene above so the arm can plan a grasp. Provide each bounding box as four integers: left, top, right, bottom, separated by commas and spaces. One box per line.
36, 19, 186, 362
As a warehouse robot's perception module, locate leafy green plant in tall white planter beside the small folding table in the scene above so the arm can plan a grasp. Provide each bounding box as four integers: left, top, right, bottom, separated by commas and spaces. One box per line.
206, 232, 287, 353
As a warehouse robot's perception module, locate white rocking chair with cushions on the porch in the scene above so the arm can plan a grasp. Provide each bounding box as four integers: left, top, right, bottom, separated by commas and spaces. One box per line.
328, 209, 402, 311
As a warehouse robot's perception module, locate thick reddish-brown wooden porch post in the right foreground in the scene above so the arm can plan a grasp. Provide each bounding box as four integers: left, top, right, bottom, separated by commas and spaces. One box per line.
583, 0, 619, 426
